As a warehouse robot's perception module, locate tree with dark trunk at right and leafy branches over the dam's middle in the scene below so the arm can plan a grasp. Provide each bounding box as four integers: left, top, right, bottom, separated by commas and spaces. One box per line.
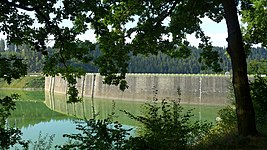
88, 0, 258, 136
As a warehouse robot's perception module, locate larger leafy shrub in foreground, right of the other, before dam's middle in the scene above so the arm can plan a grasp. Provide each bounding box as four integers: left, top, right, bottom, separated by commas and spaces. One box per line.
124, 90, 211, 150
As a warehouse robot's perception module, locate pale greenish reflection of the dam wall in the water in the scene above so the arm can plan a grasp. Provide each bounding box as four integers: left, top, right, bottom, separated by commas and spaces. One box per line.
45, 92, 222, 126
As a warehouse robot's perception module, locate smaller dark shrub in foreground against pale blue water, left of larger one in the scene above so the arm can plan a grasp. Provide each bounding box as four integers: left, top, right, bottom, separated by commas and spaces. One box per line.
56, 104, 132, 150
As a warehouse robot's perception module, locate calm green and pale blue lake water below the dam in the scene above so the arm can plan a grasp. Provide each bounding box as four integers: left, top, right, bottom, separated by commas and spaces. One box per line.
0, 90, 225, 148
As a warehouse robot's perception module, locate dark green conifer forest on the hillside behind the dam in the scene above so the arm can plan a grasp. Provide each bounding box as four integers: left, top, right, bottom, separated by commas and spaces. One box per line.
0, 39, 267, 74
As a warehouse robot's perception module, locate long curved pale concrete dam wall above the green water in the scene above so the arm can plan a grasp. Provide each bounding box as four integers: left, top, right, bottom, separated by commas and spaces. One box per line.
45, 74, 231, 105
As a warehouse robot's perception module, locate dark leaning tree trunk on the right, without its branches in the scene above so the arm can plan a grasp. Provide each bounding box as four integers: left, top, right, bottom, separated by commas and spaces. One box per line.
222, 0, 258, 136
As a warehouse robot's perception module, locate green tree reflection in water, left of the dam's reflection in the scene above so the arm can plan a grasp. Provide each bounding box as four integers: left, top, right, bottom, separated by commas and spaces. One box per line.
0, 89, 70, 128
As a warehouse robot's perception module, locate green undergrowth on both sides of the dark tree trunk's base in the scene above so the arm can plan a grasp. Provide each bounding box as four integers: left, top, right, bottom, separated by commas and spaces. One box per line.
197, 76, 267, 149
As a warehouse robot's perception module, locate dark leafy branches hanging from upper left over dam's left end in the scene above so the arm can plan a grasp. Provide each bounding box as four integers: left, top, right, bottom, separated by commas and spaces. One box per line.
0, 0, 97, 102
